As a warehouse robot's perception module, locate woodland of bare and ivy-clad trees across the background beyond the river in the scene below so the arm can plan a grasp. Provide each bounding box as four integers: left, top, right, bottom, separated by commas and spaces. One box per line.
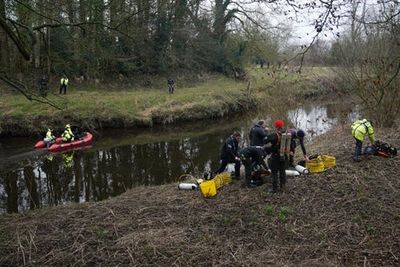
0, 0, 400, 126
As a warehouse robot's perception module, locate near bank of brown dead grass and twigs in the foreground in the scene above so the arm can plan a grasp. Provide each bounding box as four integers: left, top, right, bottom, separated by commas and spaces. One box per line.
0, 128, 400, 266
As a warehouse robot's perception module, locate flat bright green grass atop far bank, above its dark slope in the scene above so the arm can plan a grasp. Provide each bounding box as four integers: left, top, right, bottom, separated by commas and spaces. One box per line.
0, 78, 245, 117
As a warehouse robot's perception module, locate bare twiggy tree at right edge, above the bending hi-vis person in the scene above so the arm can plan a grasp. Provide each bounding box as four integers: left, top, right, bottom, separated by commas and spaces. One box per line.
337, 1, 400, 126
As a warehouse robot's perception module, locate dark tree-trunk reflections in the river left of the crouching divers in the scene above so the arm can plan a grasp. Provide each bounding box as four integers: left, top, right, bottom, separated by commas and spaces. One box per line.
0, 135, 229, 213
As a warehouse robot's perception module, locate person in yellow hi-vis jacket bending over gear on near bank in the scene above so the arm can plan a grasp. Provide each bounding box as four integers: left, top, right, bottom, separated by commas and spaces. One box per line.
351, 119, 375, 161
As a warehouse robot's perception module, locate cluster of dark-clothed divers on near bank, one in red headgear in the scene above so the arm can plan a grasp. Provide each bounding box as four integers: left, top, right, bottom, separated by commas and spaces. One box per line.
216, 120, 308, 193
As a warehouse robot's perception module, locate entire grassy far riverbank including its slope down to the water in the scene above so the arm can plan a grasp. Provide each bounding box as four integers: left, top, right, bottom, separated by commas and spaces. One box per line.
0, 68, 338, 135
